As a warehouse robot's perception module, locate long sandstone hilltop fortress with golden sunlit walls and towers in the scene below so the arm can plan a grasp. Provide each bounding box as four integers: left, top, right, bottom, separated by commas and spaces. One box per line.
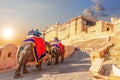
44, 16, 120, 43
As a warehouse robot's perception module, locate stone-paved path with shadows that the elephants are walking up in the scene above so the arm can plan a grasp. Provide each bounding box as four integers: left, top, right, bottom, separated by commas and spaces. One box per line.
0, 50, 92, 80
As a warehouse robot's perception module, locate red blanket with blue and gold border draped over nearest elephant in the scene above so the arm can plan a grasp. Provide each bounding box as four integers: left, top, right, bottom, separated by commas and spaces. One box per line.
24, 37, 46, 62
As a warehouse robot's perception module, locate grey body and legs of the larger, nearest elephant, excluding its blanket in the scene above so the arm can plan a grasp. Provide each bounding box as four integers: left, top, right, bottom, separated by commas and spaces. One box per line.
14, 42, 49, 78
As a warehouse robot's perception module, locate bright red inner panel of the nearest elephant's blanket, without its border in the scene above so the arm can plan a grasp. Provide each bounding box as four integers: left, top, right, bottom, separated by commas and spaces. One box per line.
33, 37, 46, 58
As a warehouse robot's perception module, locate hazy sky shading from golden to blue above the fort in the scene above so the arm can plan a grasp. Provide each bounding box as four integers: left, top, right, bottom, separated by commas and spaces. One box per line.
0, 0, 120, 45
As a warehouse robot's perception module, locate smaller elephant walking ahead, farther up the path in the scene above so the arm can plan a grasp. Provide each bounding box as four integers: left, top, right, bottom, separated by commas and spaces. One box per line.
47, 46, 64, 66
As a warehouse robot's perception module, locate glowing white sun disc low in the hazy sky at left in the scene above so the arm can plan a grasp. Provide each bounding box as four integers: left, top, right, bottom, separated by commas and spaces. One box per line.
2, 27, 13, 40
